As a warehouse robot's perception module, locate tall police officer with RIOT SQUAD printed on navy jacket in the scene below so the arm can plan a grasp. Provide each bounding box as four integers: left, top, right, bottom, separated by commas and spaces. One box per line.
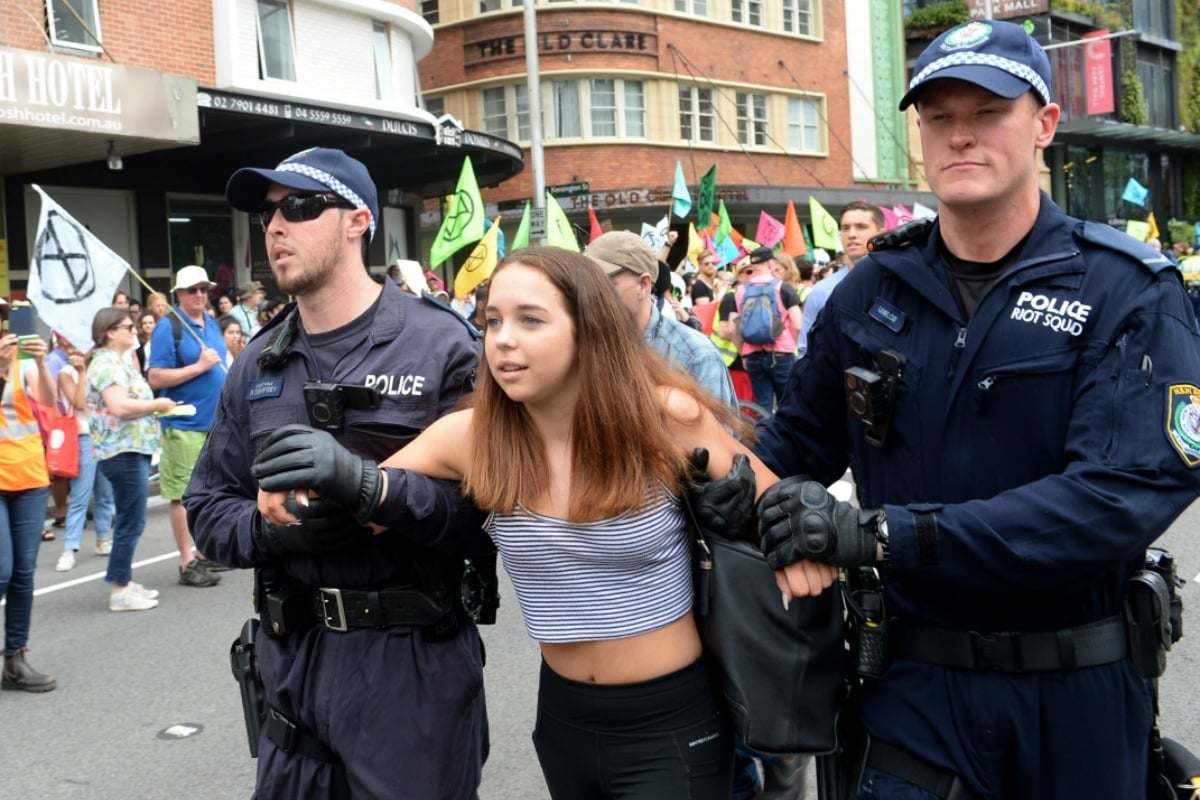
715, 20, 1200, 800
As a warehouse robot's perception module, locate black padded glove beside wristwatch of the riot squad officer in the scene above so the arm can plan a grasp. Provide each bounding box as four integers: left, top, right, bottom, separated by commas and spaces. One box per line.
758, 476, 880, 570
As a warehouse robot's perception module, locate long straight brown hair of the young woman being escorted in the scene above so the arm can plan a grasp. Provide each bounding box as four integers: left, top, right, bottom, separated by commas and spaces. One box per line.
462, 247, 749, 522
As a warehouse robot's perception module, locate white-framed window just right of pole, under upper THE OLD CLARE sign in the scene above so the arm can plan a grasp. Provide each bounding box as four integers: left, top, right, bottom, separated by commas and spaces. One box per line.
548, 78, 646, 139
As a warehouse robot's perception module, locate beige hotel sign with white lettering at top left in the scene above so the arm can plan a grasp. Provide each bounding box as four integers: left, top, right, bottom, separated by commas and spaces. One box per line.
0, 47, 200, 144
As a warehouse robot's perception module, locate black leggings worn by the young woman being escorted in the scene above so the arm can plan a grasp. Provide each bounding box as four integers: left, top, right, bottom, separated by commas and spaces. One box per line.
533, 660, 733, 800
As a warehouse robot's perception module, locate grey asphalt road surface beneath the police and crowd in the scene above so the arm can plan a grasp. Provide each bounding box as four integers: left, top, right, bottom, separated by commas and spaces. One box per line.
7, 498, 1200, 800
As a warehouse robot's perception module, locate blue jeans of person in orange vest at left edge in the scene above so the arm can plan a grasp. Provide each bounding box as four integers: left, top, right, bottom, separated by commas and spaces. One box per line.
0, 486, 50, 656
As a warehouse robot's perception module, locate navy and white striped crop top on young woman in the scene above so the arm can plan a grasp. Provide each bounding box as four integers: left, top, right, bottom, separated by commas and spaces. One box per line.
485, 492, 692, 642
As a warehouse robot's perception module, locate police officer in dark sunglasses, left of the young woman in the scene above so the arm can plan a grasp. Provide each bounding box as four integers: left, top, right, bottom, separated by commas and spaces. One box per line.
184, 148, 494, 800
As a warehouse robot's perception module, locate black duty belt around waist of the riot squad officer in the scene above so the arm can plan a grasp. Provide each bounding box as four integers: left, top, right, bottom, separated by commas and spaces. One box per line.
889, 616, 1129, 672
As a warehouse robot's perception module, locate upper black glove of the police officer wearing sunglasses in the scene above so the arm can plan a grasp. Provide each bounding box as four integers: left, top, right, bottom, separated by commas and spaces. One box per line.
250, 425, 383, 525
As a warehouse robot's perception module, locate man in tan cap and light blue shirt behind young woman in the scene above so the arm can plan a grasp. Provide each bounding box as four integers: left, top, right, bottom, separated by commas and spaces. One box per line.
583, 230, 738, 409
